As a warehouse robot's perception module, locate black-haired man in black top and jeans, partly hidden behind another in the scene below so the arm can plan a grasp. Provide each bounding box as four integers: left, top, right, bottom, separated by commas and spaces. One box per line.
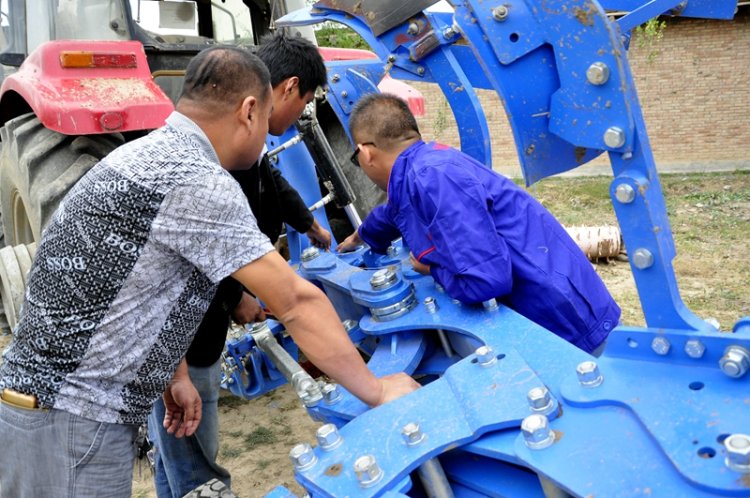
149, 34, 331, 498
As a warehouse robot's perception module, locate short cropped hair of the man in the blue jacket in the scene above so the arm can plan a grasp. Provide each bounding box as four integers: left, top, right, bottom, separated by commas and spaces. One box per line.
349, 92, 421, 150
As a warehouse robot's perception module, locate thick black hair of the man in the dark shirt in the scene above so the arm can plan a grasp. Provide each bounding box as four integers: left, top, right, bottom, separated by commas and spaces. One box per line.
256, 31, 328, 96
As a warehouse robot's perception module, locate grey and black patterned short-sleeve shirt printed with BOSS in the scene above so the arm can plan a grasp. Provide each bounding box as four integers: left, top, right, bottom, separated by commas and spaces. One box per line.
0, 113, 273, 423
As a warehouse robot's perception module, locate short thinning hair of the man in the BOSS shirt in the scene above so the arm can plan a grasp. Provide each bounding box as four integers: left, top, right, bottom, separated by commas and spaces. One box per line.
180, 45, 271, 107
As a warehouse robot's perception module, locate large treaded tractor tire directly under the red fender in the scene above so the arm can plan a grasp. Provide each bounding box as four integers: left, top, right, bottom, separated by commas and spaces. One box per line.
0, 114, 124, 246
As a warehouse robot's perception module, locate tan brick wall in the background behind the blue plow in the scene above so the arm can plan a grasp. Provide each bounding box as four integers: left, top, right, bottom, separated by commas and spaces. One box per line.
412, 7, 750, 176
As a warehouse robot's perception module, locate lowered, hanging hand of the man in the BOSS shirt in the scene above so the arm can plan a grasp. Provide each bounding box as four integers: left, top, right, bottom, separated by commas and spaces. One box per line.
162, 360, 203, 437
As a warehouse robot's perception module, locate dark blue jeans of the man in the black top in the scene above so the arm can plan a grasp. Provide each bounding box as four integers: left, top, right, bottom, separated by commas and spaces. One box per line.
148, 360, 230, 498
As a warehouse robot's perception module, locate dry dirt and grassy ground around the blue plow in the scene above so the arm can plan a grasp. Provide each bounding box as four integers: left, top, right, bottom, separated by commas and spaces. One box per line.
0, 173, 750, 498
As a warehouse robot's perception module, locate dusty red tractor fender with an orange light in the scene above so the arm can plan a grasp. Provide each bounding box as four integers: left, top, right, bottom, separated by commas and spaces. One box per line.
0, 40, 174, 135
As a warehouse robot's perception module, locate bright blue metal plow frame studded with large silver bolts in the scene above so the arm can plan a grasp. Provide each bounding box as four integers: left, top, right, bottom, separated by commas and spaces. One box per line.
225, 0, 750, 497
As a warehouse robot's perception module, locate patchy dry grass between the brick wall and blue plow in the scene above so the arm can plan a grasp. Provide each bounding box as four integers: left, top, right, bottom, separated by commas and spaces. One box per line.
528, 171, 750, 330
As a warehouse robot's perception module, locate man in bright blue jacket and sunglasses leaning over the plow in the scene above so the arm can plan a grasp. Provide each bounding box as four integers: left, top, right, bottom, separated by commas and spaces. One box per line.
338, 94, 620, 354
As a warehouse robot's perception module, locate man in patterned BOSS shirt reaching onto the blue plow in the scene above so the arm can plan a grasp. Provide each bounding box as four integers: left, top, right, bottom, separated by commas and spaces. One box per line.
0, 47, 417, 498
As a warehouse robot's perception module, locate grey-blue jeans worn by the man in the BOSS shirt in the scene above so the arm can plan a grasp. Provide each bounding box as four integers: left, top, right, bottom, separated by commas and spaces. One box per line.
0, 402, 138, 498
